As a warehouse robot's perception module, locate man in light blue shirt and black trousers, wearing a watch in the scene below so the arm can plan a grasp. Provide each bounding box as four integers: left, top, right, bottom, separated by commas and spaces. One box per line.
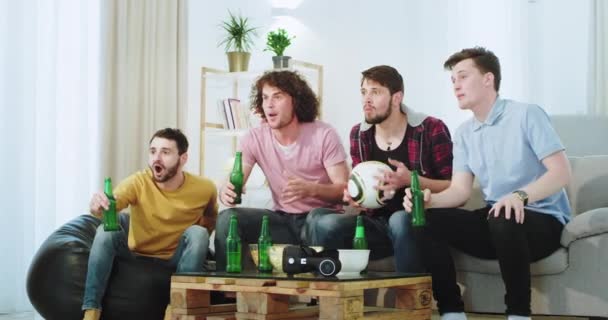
404, 47, 571, 320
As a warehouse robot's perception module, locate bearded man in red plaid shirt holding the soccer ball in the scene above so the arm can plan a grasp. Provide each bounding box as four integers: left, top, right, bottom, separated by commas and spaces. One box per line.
309, 66, 452, 272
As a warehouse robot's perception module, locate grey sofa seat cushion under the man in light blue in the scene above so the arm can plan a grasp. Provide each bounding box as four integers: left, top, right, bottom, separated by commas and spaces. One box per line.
452, 248, 568, 276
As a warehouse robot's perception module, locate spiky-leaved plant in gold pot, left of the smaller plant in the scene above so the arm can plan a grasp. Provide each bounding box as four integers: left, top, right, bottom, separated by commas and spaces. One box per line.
218, 11, 257, 72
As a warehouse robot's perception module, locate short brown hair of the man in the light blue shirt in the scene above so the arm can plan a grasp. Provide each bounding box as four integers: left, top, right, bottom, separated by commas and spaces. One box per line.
443, 47, 501, 92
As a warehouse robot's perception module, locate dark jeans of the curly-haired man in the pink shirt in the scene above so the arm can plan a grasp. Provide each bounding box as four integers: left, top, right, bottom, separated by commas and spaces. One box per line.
215, 208, 308, 271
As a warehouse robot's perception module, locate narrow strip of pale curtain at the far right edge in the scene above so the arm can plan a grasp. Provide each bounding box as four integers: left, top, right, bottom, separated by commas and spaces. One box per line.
589, 0, 608, 116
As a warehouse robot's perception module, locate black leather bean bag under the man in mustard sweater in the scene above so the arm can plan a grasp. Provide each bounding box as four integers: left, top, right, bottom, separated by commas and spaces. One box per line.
27, 213, 174, 320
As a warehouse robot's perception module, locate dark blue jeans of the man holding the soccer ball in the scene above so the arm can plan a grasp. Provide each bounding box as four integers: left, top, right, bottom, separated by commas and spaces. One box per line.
307, 208, 424, 272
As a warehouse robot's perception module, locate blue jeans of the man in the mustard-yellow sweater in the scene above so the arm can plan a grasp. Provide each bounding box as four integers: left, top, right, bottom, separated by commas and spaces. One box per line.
82, 224, 209, 310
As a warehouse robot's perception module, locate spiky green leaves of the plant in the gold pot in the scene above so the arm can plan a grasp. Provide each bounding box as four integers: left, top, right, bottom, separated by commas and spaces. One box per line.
218, 11, 258, 52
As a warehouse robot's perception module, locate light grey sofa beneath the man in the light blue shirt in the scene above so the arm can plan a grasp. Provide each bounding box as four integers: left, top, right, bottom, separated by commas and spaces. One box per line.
366, 115, 608, 317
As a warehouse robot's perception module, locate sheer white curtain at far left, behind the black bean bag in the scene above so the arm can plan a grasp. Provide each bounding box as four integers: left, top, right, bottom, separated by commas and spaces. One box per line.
0, 0, 103, 313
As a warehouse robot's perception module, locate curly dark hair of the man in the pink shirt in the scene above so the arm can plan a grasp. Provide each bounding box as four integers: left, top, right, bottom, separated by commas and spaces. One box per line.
250, 70, 319, 122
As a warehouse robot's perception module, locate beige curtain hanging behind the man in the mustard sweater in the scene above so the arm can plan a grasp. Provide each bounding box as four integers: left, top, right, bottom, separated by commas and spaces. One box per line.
102, 0, 187, 181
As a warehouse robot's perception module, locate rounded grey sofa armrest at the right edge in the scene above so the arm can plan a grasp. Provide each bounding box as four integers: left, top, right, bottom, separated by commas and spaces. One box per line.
561, 208, 608, 248
